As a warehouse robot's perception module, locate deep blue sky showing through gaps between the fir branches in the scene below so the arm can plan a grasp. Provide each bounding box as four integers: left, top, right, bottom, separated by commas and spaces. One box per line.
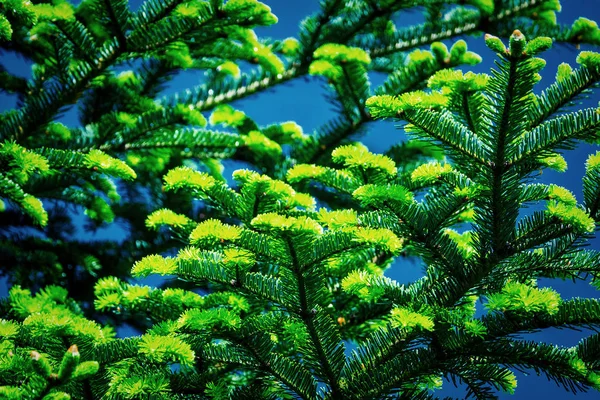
0, 0, 600, 399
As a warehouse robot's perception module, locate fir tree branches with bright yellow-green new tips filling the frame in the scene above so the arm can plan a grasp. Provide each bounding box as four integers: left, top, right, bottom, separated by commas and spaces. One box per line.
0, 0, 600, 399
